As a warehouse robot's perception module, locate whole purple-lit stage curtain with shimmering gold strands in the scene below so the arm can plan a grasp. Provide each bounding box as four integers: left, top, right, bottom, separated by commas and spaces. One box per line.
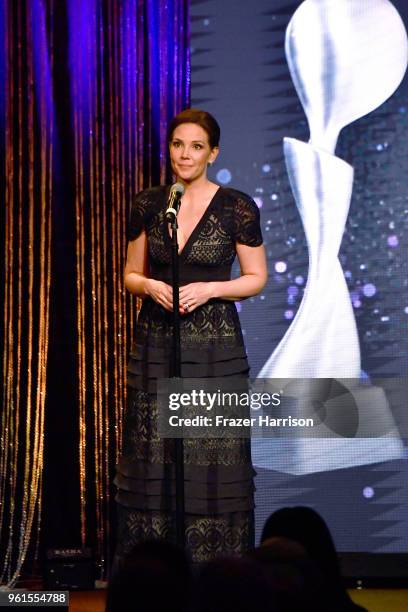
0, 0, 190, 584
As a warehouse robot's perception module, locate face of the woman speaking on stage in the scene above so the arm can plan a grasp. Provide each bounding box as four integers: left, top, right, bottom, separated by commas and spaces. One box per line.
170, 123, 218, 183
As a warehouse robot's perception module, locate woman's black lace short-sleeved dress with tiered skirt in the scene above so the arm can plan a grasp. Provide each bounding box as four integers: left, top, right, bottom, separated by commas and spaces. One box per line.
115, 187, 262, 562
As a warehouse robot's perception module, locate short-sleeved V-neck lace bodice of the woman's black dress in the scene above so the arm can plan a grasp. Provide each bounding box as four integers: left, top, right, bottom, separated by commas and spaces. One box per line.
134, 187, 262, 285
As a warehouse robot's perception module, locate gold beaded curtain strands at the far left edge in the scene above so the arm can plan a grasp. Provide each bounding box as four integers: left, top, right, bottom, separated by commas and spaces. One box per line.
0, 2, 53, 584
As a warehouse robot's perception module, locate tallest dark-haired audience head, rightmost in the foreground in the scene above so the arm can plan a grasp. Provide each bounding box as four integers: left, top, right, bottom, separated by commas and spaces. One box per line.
261, 506, 364, 611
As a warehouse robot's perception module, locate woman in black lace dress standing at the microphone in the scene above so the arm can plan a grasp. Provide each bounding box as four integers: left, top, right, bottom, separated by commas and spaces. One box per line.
115, 109, 267, 562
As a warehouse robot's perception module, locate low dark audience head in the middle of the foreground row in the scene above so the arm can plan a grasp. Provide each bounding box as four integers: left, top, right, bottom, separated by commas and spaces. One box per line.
193, 557, 280, 612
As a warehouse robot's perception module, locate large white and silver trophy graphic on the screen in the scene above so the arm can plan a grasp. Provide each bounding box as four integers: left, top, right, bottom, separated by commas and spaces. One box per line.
253, 0, 408, 473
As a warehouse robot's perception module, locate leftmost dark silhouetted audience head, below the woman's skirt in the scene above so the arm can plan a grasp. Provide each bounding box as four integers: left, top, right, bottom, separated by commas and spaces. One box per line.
106, 540, 192, 612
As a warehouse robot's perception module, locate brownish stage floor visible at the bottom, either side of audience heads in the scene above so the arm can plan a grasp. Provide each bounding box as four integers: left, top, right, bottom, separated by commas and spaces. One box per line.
69, 589, 408, 612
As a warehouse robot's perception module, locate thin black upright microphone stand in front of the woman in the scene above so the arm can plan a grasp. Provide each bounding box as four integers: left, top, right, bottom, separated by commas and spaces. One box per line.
170, 215, 185, 549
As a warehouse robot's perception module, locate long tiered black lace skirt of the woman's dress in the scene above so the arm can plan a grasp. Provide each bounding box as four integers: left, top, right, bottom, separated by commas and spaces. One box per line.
114, 300, 255, 561
